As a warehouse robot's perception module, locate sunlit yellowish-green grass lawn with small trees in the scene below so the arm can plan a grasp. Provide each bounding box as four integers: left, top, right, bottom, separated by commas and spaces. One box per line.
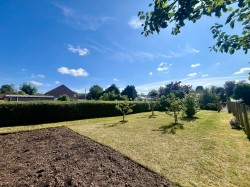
0, 111, 250, 187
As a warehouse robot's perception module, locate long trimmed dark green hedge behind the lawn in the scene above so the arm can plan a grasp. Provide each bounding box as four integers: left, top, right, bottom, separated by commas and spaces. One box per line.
0, 101, 148, 127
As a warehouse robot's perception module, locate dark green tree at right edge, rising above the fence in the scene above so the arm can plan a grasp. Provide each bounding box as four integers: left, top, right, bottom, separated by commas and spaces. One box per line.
233, 83, 250, 105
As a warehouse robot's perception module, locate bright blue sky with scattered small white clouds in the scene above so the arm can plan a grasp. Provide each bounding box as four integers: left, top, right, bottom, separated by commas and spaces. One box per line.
0, 0, 250, 93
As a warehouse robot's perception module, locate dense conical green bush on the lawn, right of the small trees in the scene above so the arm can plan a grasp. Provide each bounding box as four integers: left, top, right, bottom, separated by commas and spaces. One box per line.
183, 94, 199, 118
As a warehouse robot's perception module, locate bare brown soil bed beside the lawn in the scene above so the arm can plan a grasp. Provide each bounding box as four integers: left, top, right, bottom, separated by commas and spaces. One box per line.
0, 127, 171, 186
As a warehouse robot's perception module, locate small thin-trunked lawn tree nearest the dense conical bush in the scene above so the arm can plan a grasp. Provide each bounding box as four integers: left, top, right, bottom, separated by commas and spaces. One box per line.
166, 93, 183, 125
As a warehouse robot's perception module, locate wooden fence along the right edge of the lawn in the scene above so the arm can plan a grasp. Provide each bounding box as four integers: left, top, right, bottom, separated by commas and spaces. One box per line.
227, 101, 250, 139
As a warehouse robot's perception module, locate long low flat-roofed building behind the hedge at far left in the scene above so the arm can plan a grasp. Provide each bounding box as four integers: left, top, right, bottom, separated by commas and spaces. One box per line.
4, 95, 54, 101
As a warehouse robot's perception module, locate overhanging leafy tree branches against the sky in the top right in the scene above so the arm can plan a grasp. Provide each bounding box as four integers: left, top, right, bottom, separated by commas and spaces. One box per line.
138, 0, 250, 54
